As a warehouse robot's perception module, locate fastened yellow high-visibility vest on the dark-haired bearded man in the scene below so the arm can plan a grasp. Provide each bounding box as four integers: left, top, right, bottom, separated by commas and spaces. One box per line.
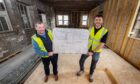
88, 27, 108, 52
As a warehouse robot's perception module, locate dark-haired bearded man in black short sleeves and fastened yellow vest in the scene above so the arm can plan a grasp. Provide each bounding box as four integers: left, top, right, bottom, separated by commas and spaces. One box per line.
77, 15, 108, 82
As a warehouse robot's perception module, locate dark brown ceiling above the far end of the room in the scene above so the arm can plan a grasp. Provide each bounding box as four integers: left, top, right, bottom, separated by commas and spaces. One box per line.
40, 0, 105, 10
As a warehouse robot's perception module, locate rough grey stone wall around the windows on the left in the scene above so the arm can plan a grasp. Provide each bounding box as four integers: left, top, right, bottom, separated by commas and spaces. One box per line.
0, 0, 52, 58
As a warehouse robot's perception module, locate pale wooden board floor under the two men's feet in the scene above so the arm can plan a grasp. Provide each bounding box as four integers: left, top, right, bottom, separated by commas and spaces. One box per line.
25, 49, 140, 84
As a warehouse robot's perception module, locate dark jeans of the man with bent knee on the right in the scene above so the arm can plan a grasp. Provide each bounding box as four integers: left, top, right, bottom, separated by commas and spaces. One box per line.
79, 52, 100, 75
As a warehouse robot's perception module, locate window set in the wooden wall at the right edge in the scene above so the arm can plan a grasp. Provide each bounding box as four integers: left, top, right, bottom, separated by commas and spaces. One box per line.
130, 9, 140, 38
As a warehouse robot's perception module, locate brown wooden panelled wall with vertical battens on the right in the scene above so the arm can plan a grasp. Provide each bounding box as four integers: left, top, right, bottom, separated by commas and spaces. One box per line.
90, 0, 140, 69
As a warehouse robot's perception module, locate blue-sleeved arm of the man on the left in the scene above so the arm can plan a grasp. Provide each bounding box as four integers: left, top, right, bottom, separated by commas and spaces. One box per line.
32, 40, 48, 56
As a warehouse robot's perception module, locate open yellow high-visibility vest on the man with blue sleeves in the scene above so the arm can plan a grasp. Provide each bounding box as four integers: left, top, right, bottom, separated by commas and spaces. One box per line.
32, 30, 53, 58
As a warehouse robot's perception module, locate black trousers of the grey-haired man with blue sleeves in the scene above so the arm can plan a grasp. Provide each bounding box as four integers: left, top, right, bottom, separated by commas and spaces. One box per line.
42, 54, 58, 75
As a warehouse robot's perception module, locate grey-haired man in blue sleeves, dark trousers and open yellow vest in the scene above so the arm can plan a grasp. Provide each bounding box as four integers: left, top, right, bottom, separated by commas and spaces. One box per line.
32, 22, 58, 82
